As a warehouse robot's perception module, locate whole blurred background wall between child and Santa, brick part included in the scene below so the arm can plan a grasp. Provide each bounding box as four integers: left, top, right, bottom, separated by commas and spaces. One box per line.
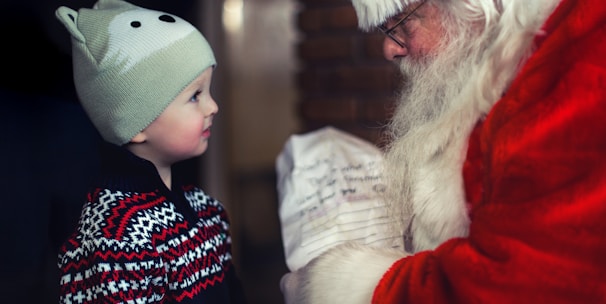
221, 0, 399, 303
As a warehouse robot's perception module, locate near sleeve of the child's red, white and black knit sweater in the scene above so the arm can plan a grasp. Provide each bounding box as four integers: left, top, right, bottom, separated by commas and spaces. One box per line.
58, 190, 167, 303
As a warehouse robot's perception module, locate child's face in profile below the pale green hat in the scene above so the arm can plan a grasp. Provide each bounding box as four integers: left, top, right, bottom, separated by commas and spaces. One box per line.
138, 67, 219, 165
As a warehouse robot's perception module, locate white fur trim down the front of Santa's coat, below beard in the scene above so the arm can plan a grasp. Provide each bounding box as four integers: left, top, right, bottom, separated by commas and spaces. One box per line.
412, 114, 482, 252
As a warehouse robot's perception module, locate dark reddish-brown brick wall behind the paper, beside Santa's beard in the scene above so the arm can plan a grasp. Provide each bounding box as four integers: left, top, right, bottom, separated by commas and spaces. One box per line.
297, 0, 400, 145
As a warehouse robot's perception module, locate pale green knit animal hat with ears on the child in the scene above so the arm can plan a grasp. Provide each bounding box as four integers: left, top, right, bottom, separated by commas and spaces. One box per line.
56, 0, 216, 145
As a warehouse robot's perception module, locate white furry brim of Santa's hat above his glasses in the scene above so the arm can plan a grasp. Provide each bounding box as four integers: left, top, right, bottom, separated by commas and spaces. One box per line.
351, 0, 421, 30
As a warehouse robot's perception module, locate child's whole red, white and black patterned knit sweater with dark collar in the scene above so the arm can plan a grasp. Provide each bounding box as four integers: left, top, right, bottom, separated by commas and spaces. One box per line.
59, 144, 244, 303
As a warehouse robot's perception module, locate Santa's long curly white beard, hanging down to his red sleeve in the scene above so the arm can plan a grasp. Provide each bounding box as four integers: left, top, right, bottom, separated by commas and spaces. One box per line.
385, 0, 557, 253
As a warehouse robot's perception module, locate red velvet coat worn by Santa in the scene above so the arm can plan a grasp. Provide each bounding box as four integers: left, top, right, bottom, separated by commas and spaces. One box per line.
373, 0, 606, 304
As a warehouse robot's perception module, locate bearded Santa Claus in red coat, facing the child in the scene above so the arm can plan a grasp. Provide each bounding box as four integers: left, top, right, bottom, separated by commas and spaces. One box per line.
281, 0, 606, 304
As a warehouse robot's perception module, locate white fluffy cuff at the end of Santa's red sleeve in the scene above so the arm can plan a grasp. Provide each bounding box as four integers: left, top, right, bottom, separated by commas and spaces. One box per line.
281, 243, 406, 304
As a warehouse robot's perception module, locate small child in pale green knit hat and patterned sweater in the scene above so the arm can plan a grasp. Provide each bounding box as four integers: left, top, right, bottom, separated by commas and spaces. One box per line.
56, 0, 244, 303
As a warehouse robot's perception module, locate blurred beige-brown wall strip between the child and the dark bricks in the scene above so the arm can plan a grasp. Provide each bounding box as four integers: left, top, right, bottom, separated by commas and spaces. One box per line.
221, 0, 301, 304
